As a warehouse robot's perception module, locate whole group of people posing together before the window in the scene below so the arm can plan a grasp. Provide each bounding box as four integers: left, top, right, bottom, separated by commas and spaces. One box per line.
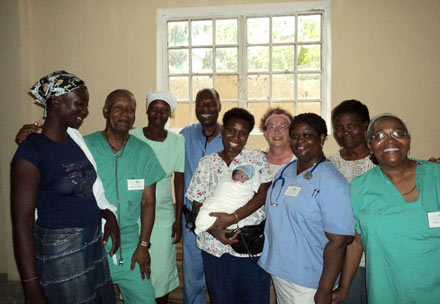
11, 71, 440, 303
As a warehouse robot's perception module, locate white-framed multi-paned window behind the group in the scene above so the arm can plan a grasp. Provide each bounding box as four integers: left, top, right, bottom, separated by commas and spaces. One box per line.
158, 1, 331, 129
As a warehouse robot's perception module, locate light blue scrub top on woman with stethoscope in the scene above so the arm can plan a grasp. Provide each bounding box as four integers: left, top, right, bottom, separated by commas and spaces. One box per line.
258, 161, 354, 289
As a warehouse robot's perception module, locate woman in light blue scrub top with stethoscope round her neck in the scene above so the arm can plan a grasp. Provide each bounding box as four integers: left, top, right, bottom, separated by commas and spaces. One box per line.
258, 113, 354, 303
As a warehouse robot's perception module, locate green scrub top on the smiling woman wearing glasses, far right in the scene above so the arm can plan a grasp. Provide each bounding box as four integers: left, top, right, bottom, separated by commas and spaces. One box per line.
351, 160, 440, 304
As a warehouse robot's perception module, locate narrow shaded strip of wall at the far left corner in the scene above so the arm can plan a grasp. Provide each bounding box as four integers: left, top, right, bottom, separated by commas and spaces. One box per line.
0, 0, 33, 279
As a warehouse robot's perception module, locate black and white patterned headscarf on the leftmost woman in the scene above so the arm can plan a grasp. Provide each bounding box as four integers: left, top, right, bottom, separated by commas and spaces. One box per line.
29, 71, 87, 117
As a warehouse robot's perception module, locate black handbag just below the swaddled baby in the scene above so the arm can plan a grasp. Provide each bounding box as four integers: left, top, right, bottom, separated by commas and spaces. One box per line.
229, 220, 266, 256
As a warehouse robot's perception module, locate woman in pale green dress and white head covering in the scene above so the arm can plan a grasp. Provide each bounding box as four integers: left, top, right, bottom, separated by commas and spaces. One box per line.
131, 91, 185, 303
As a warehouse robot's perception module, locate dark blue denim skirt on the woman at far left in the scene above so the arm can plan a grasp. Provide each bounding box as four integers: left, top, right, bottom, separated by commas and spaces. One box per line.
34, 225, 116, 304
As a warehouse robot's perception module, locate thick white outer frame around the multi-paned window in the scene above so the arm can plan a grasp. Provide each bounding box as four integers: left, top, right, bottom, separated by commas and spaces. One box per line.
156, 0, 331, 134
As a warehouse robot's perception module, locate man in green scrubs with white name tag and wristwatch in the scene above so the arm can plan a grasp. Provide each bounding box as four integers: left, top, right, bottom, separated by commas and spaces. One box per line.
84, 90, 165, 304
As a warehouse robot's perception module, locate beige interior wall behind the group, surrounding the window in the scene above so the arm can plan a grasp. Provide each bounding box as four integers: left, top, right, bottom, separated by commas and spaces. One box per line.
0, 0, 440, 278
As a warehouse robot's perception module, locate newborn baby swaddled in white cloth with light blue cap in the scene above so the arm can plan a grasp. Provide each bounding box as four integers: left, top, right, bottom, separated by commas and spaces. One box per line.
194, 165, 261, 234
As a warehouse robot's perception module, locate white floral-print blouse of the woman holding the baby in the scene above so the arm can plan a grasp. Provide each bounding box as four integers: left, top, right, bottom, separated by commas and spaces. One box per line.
185, 150, 272, 257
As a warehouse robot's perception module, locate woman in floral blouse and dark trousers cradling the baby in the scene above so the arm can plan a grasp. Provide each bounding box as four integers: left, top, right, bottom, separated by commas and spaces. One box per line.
186, 108, 272, 303
